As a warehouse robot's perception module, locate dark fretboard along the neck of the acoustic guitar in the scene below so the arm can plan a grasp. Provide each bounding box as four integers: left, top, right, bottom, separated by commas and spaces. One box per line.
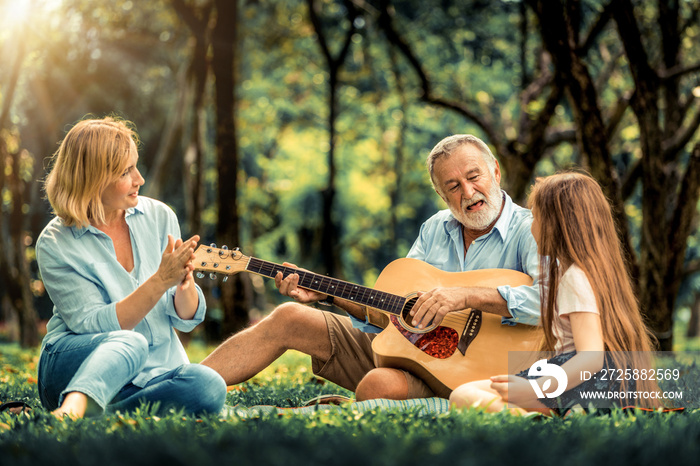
246, 257, 406, 315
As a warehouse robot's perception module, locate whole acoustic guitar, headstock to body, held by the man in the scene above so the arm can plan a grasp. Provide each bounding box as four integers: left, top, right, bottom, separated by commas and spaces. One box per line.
194, 245, 541, 393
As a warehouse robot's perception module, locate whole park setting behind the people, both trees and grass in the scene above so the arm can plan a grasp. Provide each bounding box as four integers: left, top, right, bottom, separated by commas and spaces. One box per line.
0, 0, 700, 466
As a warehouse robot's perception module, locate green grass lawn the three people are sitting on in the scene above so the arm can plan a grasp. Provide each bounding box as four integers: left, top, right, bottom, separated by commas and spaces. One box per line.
0, 345, 700, 466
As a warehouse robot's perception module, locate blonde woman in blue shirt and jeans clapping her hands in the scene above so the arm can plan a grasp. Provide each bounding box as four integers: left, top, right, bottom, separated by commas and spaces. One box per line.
36, 117, 226, 418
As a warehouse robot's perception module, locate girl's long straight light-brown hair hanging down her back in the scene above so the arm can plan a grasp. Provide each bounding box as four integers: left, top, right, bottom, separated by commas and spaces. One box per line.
528, 172, 658, 401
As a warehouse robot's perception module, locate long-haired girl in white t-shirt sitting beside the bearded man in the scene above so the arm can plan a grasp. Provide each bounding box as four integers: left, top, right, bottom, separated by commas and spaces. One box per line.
450, 173, 658, 414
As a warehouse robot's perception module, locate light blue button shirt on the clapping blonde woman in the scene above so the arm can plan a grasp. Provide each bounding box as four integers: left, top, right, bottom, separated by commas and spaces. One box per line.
36, 196, 206, 387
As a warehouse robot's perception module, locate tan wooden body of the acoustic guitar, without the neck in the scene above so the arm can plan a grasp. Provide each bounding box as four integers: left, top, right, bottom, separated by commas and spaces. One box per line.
368, 258, 542, 393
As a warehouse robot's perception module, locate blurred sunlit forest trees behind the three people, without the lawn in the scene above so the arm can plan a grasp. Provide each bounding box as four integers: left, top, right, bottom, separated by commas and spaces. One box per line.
0, 0, 700, 350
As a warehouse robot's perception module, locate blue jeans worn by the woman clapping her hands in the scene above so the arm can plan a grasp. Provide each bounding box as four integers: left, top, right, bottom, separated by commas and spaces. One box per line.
38, 330, 226, 415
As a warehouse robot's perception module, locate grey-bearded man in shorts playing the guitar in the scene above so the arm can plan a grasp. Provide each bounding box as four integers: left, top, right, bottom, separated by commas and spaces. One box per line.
202, 135, 540, 400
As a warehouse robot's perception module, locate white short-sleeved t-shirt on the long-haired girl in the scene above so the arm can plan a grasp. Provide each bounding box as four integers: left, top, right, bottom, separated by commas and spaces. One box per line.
552, 265, 600, 354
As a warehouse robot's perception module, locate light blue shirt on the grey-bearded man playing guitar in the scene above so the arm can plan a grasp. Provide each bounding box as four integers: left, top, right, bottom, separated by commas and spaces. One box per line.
351, 192, 540, 333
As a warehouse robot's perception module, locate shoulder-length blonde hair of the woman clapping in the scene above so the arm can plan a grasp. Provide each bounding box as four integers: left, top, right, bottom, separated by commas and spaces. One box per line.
44, 117, 138, 226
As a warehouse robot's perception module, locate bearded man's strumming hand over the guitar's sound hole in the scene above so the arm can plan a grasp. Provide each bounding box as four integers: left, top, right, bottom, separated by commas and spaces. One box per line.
411, 287, 470, 328
